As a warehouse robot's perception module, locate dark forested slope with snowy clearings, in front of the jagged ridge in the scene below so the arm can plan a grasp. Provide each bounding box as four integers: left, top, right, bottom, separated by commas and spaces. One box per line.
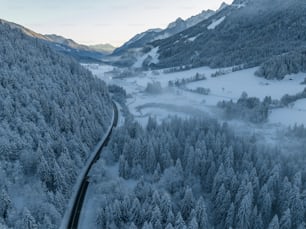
140, 0, 306, 71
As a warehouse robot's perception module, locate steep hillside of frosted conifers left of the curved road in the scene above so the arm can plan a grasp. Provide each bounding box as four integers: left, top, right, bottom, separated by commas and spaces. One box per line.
0, 23, 112, 229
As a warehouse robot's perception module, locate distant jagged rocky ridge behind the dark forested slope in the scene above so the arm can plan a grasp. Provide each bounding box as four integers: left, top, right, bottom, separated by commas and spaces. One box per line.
113, 10, 215, 55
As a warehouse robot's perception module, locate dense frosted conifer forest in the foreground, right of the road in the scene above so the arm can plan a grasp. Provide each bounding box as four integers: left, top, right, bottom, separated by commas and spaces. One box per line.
92, 118, 306, 229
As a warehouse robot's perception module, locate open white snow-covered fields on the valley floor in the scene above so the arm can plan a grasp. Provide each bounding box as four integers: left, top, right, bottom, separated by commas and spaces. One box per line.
86, 65, 306, 126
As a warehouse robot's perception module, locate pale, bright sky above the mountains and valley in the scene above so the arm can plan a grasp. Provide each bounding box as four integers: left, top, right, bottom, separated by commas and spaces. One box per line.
0, 0, 233, 46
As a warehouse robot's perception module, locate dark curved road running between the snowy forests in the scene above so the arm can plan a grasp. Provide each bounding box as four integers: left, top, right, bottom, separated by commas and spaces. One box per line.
68, 102, 118, 229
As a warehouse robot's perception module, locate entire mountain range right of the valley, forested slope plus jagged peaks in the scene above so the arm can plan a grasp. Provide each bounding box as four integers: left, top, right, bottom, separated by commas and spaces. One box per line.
110, 0, 306, 78
